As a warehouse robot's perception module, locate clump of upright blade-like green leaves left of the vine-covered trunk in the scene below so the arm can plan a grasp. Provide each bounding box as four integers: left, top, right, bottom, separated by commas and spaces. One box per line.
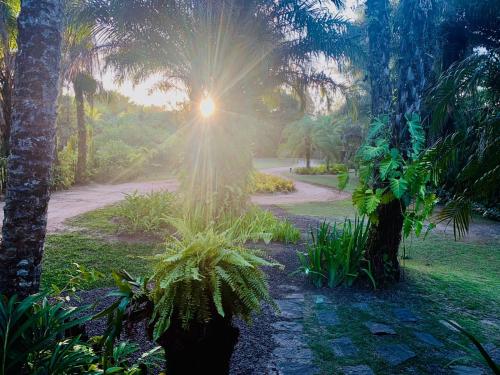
298, 218, 375, 288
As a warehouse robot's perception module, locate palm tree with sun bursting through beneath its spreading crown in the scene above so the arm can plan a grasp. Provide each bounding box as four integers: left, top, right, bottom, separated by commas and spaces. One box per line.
86, 0, 356, 219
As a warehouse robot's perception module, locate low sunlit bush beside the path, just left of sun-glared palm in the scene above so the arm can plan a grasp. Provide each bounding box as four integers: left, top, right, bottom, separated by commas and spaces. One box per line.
116, 191, 180, 233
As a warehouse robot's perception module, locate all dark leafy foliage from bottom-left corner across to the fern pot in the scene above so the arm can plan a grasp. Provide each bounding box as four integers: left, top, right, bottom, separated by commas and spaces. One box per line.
0, 294, 159, 375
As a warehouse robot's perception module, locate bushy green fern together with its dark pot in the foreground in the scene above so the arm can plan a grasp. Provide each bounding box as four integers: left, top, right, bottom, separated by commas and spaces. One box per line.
122, 229, 278, 375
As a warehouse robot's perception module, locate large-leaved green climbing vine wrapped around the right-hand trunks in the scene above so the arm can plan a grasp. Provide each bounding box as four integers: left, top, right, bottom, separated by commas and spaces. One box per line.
346, 114, 443, 237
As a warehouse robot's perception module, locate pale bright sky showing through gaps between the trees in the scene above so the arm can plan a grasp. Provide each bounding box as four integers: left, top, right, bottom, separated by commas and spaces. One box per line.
102, 0, 362, 110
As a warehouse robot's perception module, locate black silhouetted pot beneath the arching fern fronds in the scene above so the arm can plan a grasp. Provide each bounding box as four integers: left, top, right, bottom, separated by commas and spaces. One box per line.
158, 315, 239, 375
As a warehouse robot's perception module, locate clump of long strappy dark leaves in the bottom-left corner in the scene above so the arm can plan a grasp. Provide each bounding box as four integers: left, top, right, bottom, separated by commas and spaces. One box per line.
0, 295, 94, 375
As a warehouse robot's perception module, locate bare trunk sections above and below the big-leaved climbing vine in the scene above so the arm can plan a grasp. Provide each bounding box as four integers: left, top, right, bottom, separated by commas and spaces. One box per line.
365, 0, 403, 286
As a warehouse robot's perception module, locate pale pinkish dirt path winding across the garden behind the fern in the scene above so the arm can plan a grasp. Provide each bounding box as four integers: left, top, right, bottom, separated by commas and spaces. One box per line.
0, 167, 347, 232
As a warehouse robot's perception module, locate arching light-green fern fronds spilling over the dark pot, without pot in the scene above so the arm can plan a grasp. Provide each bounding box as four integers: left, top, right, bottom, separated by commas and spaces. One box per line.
151, 229, 277, 339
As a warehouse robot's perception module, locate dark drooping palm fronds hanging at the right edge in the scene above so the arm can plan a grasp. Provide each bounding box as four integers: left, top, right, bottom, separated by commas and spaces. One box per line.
429, 48, 500, 236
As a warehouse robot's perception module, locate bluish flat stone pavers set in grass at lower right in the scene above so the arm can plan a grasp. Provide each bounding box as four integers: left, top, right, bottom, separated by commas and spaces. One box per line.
268, 285, 492, 375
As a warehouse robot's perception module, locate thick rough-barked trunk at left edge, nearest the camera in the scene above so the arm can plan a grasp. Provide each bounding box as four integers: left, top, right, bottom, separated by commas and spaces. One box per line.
0, 0, 63, 297
